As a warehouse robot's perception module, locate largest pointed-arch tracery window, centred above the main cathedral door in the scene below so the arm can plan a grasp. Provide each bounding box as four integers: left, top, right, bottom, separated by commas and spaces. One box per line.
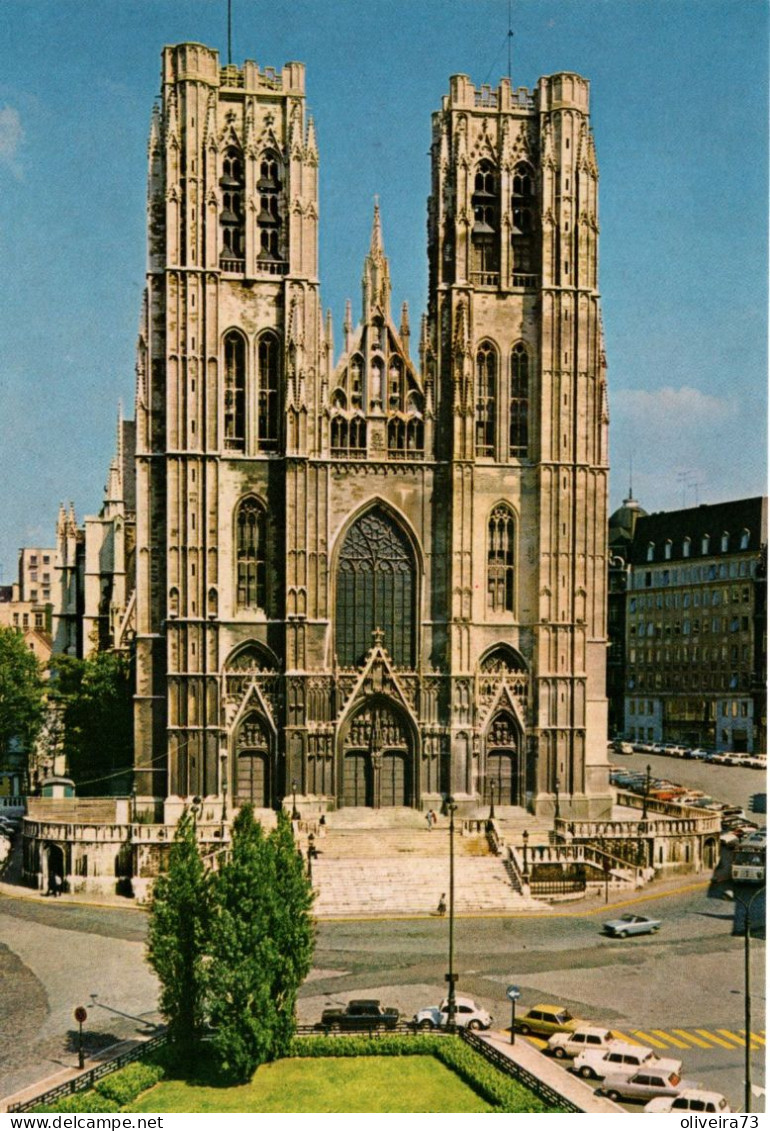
336, 507, 417, 668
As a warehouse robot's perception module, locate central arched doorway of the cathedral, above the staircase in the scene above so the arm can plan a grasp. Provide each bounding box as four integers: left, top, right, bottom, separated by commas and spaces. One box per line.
340, 700, 414, 809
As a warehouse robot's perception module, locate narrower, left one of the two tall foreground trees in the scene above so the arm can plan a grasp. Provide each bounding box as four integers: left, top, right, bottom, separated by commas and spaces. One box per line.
147, 812, 211, 1056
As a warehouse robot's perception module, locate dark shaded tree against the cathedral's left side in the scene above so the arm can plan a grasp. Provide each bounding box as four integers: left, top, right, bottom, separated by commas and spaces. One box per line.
51, 651, 133, 796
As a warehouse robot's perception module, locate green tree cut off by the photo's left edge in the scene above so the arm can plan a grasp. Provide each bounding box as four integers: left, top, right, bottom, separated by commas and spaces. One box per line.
0, 628, 45, 768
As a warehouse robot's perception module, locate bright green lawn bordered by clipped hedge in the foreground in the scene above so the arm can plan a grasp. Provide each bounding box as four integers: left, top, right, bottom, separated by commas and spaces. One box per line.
127, 1056, 493, 1112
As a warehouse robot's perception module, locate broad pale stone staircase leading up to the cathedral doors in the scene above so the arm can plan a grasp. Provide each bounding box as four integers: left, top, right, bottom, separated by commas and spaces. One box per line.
301, 810, 547, 918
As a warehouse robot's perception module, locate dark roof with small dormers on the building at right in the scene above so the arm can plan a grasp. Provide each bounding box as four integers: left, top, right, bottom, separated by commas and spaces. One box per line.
629, 495, 768, 566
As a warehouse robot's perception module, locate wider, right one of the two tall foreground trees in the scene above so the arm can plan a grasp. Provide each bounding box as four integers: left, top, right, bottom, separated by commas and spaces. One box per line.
209, 805, 314, 1082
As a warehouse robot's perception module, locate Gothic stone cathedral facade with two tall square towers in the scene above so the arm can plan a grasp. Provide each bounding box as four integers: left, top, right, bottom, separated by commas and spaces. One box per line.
133, 43, 611, 820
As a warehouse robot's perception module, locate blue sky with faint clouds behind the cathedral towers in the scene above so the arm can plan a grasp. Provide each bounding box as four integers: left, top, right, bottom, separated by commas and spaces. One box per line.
0, 0, 768, 584
